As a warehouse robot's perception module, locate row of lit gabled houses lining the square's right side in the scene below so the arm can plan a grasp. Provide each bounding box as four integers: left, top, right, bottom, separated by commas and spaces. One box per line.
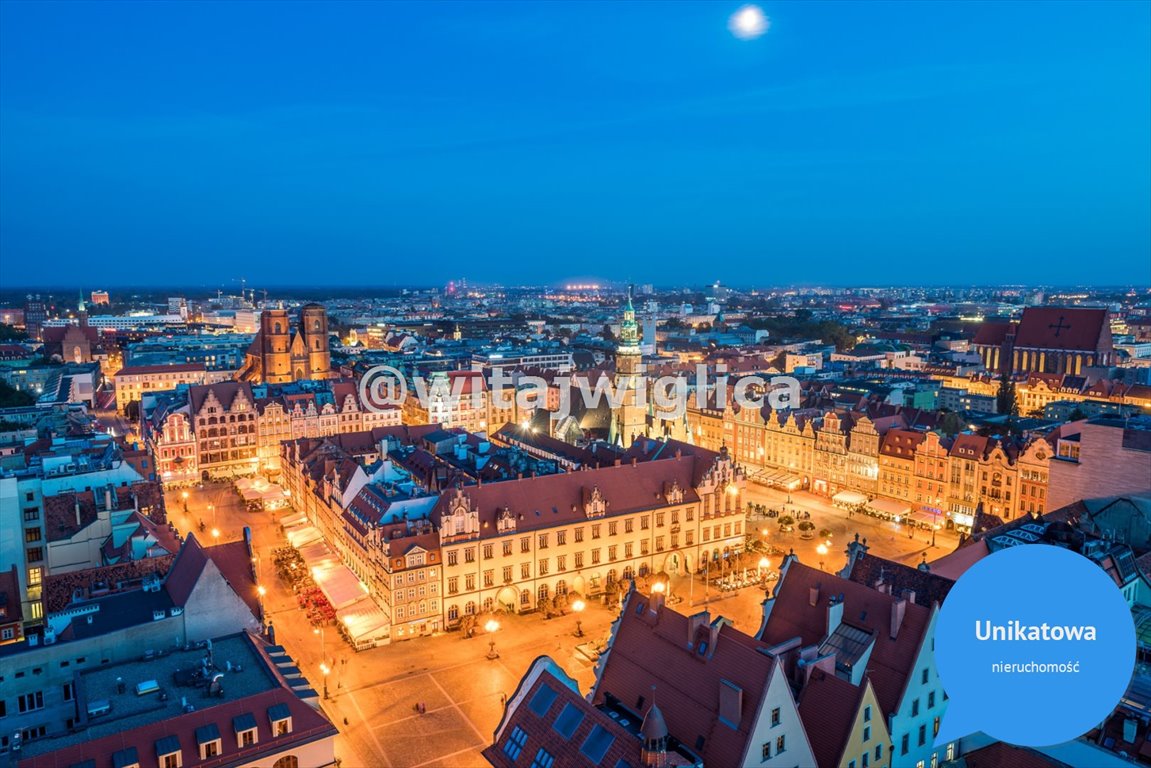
687, 396, 1055, 530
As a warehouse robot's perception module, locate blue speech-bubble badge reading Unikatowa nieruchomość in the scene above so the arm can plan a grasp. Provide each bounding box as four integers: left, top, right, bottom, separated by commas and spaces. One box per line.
935, 545, 1135, 746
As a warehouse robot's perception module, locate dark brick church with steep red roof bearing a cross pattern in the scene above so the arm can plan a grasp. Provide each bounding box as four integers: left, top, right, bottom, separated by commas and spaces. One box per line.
971, 306, 1115, 375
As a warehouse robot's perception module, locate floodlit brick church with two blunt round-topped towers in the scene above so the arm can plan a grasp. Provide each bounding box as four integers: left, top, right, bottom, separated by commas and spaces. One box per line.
237, 304, 331, 383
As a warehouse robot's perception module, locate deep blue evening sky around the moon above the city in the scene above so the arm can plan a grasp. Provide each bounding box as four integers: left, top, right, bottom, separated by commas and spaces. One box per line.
0, 0, 1151, 287
